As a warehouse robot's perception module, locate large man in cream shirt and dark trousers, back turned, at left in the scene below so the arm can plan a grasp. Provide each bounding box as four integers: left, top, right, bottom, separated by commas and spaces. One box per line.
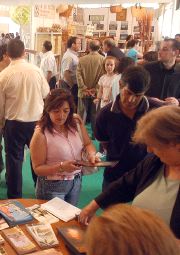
0, 39, 49, 198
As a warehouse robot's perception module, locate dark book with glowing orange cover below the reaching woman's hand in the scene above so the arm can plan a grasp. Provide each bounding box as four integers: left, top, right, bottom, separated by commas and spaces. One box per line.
58, 225, 86, 255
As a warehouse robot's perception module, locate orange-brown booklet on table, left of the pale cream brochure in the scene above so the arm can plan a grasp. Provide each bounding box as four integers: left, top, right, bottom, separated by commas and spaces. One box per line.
2, 227, 37, 254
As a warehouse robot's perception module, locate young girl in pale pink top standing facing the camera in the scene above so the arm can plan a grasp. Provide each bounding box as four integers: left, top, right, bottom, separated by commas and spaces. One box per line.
94, 56, 118, 108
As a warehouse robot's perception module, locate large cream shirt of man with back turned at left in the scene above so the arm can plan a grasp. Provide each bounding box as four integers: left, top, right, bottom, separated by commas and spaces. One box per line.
0, 59, 49, 128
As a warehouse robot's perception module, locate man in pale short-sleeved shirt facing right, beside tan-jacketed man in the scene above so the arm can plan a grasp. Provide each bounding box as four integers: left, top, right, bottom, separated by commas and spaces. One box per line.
61, 36, 81, 106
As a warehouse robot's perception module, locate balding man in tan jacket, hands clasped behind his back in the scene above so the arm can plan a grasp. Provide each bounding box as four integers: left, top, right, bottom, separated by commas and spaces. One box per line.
76, 40, 104, 137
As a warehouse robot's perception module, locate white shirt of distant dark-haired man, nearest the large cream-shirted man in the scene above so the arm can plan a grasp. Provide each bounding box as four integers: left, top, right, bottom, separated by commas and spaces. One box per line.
40, 51, 57, 79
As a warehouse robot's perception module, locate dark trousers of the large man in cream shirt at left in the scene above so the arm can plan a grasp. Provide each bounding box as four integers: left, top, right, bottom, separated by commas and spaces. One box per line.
4, 120, 37, 198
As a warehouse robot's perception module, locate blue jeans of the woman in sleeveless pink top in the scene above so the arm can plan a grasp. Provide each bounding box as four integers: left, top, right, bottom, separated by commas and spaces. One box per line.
36, 174, 82, 206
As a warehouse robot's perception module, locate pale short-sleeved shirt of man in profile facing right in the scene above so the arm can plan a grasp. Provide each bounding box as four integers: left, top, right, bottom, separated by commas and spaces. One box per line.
61, 49, 79, 84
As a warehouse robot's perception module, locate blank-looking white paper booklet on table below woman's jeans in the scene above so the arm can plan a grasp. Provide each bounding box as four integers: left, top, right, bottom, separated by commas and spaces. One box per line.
41, 197, 81, 222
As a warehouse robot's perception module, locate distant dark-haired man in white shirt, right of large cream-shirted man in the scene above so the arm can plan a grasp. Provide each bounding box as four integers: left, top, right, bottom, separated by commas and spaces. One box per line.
40, 41, 57, 89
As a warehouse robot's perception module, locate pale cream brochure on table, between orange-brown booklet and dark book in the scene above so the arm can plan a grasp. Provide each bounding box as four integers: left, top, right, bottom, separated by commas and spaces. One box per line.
26, 223, 59, 248
